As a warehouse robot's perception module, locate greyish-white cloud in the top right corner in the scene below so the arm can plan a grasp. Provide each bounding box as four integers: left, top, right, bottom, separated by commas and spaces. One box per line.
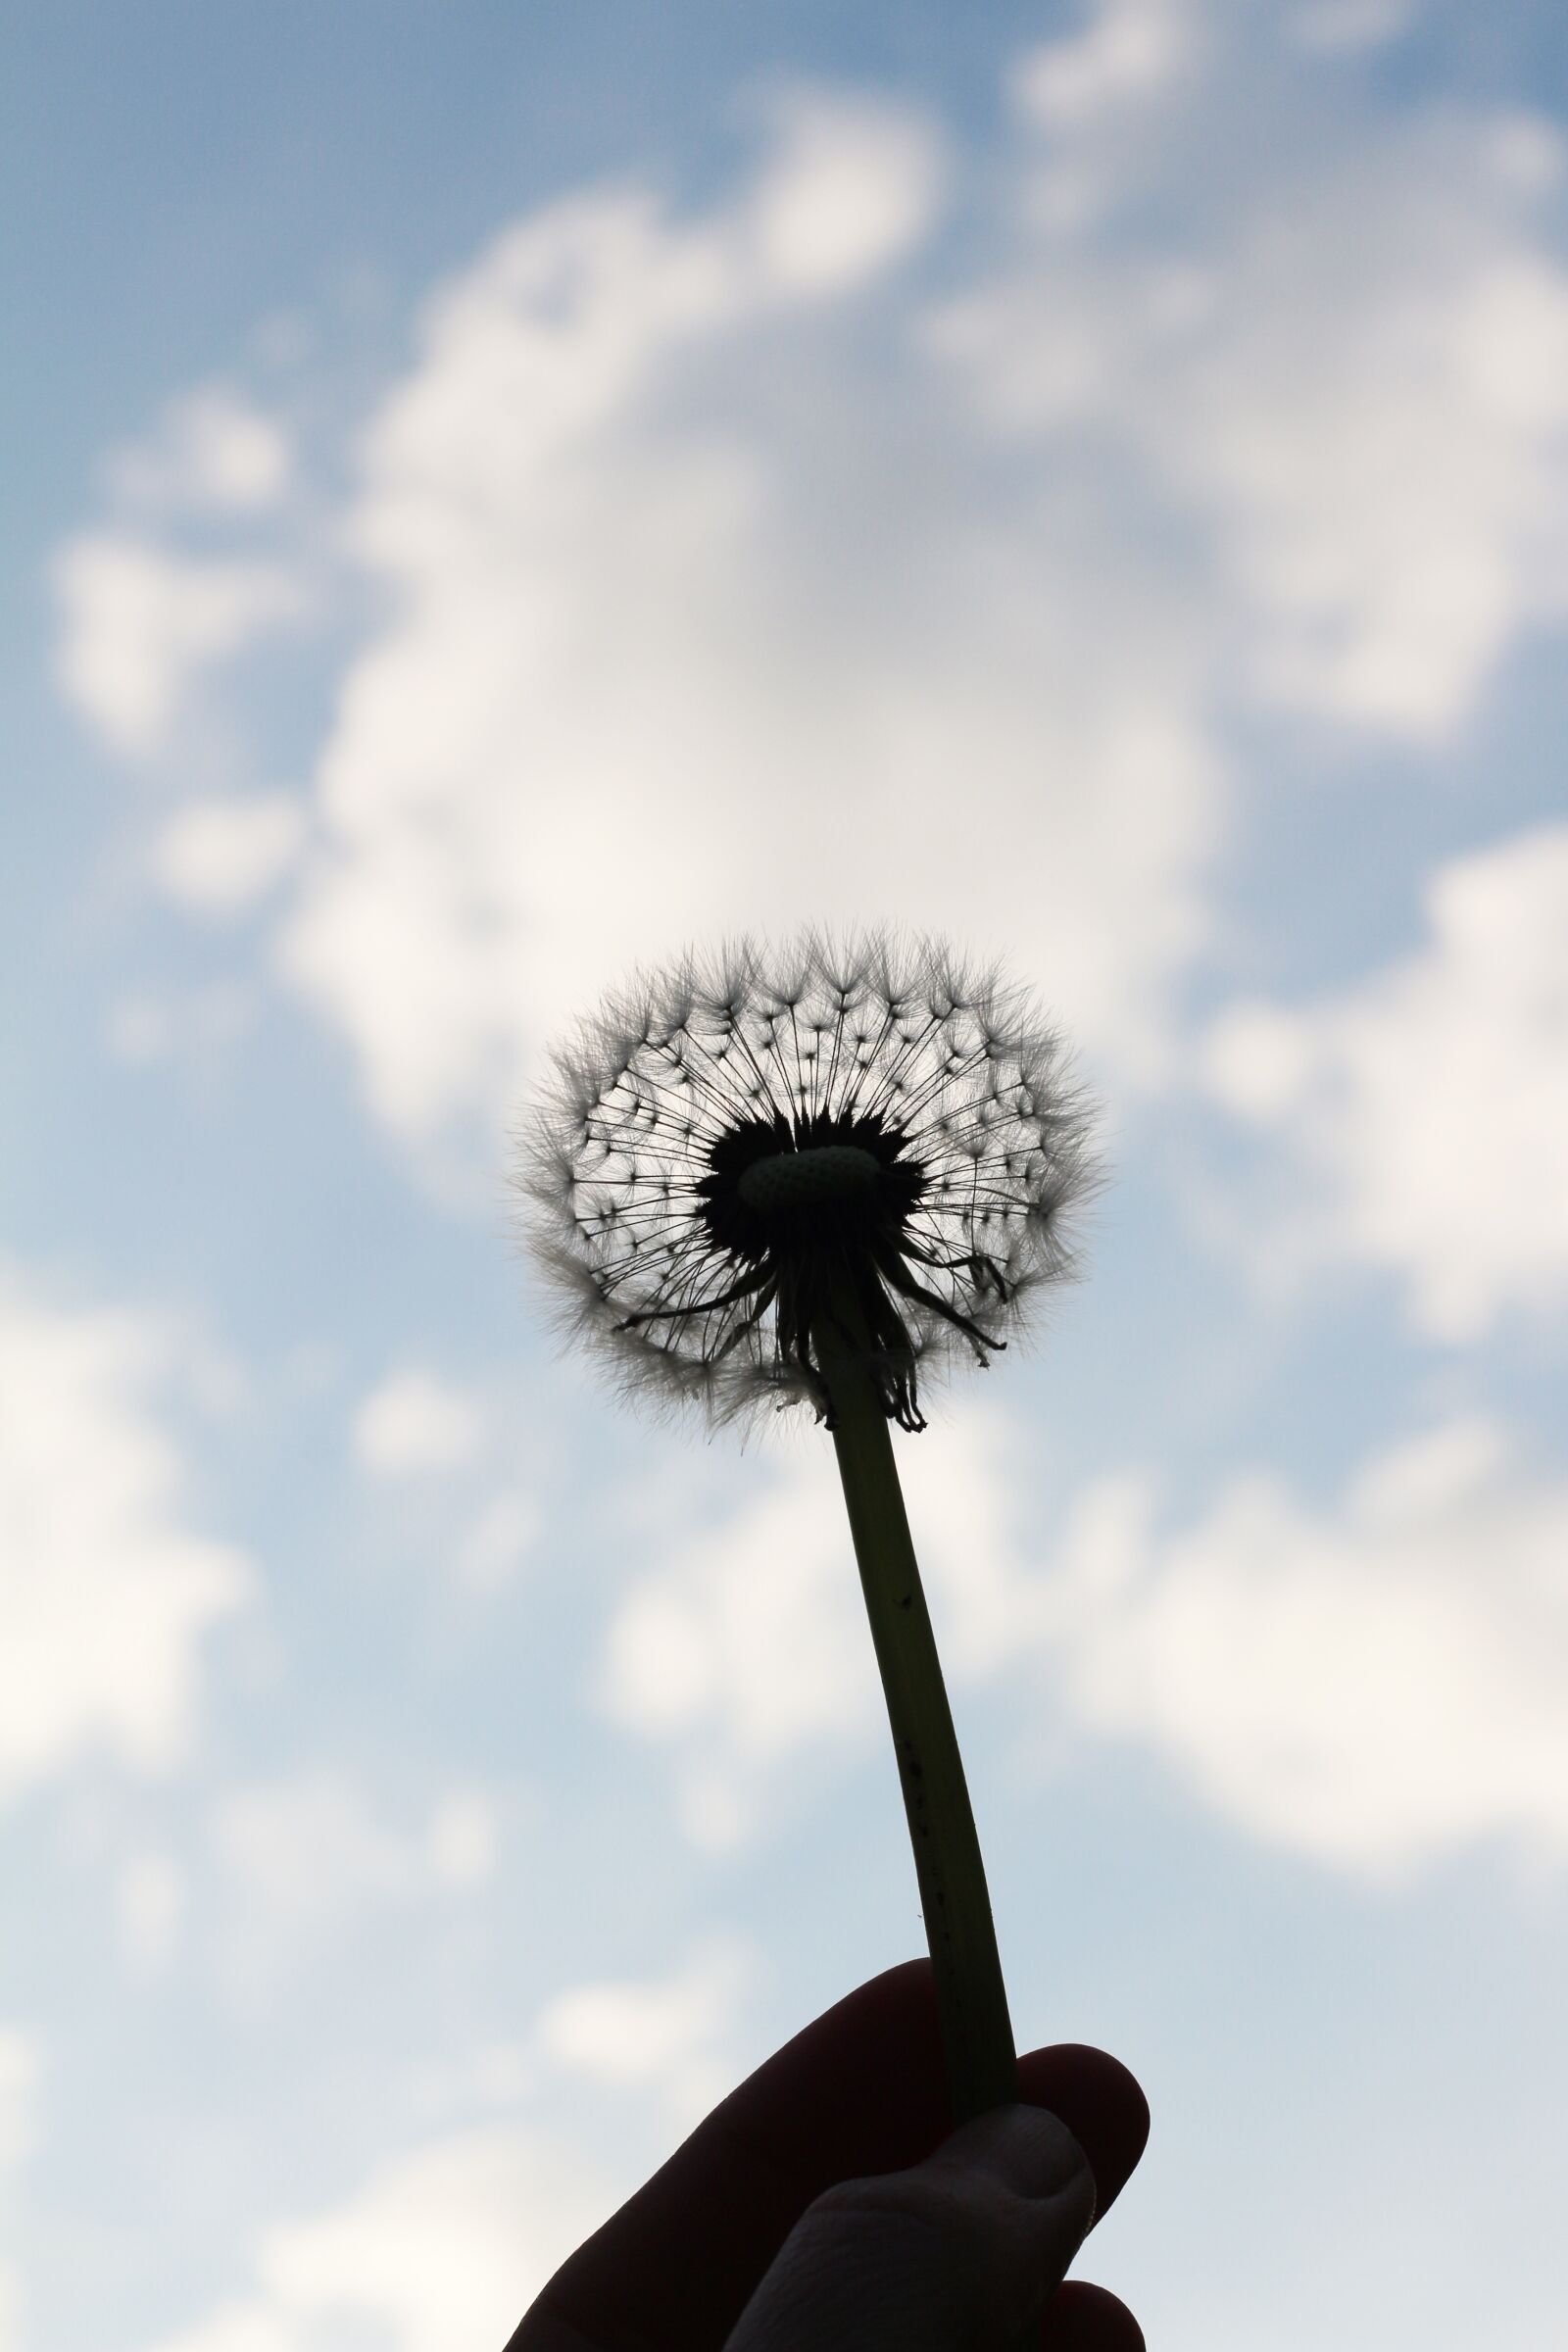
936, 18, 1568, 739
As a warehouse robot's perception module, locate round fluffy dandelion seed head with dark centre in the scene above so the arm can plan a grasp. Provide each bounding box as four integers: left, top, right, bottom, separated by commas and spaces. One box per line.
517, 931, 1096, 1430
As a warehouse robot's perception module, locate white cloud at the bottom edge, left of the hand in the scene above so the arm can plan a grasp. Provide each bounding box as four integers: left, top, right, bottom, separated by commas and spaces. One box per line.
145, 2129, 613, 2352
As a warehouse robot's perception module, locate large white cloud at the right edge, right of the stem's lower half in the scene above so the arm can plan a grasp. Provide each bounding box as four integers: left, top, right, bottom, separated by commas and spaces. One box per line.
1051, 1423, 1568, 1877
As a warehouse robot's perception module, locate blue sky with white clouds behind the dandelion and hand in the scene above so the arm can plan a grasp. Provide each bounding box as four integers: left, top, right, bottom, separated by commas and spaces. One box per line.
0, 0, 1568, 2352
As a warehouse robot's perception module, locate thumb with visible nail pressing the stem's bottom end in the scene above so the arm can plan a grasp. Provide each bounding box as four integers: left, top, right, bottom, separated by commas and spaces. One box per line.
726, 2107, 1096, 2352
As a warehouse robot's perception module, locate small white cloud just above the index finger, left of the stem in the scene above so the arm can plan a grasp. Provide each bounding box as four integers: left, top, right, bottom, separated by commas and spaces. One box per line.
536, 1936, 755, 2131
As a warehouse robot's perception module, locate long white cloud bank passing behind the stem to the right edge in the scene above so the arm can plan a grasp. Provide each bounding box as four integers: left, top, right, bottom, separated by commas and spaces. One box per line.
602, 1409, 1568, 1875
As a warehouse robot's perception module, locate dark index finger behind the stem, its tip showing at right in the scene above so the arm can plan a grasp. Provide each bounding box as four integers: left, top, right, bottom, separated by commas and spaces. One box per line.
508, 1959, 1150, 2352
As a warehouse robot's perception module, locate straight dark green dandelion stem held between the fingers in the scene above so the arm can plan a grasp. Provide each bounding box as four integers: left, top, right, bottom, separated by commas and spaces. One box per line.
823, 1307, 1018, 2127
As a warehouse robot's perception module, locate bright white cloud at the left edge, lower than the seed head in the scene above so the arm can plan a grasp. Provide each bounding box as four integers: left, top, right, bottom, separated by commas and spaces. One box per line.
0, 1275, 252, 1794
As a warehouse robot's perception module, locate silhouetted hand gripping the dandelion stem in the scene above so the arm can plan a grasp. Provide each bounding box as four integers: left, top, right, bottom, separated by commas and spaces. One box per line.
506, 1959, 1150, 2352
